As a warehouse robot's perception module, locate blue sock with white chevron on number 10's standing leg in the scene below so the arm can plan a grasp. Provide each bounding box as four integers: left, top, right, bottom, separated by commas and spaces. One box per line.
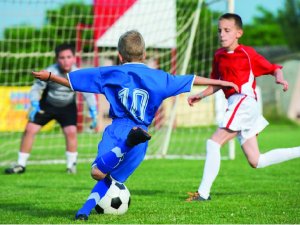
76, 177, 111, 216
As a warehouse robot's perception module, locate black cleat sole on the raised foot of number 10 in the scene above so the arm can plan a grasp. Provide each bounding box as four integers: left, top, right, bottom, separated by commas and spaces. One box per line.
126, 127, 151, 147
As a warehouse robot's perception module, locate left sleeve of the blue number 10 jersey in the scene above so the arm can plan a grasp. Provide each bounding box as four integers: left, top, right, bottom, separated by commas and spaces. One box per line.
68, 68, 102, 93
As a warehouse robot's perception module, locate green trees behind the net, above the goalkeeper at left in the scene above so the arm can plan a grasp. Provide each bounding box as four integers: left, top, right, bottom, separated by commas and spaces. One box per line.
0, 2, 93, 85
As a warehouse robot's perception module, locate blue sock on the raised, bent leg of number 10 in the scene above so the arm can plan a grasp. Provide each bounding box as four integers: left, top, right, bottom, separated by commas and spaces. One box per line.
95, 143, 130, 174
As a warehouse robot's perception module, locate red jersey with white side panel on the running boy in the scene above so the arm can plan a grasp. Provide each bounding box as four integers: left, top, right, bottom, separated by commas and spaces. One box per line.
210, 45, 282, 98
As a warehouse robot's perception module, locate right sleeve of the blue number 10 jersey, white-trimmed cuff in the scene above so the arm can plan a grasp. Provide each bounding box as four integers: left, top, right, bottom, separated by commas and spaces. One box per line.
166, 74, 195, 97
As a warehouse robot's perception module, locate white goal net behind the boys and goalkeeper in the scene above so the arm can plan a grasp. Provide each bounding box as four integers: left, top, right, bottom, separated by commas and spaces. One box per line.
0, 0, 234, 165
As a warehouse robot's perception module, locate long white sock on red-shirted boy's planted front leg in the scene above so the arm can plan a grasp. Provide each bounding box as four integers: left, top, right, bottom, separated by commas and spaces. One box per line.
198, 139, 221, 199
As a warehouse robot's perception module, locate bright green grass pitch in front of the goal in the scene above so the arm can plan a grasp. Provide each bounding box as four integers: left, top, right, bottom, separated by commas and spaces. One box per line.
0, 124, 300, 224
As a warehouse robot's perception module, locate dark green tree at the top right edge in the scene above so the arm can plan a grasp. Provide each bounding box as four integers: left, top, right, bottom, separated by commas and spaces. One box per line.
278, 0, 300, 52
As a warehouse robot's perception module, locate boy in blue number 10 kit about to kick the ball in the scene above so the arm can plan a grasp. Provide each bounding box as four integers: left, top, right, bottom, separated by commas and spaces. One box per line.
32, 30, 238, 220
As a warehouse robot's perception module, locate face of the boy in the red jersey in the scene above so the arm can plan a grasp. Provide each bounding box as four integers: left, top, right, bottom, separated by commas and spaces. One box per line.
218, 19, 243, 51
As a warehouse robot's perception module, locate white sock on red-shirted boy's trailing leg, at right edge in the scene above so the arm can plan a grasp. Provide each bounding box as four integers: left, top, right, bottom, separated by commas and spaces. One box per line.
257, 146, 300, 168
